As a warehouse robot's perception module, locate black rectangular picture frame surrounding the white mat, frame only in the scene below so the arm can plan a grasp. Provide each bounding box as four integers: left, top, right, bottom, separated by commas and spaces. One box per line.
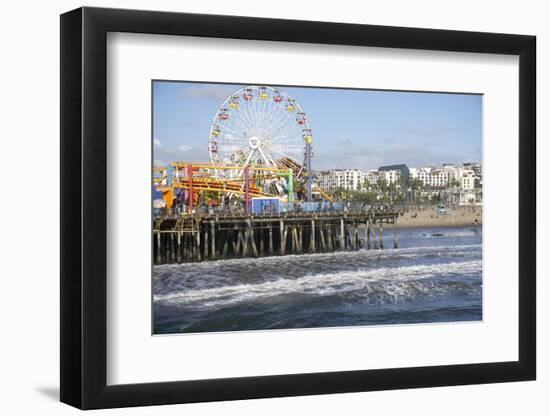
60, 7, 536, 409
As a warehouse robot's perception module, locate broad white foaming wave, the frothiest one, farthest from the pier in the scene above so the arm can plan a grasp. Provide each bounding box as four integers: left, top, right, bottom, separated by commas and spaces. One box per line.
153, 258, 482, 309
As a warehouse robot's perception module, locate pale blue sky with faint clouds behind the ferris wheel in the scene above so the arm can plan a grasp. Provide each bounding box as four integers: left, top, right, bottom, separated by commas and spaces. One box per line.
153, 81, 482, 170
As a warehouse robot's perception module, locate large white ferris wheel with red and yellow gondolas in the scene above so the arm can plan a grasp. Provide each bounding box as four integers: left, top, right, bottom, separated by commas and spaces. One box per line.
208, 86, 312, 178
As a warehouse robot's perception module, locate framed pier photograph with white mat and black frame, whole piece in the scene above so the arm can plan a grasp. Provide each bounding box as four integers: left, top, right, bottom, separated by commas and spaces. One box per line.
61, 8, 536, 409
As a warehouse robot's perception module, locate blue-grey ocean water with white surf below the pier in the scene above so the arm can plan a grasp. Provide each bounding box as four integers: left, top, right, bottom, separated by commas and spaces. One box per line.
152, 227, 482, 334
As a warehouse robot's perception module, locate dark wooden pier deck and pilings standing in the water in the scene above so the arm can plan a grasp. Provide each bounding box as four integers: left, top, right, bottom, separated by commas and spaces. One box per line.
153, 211, 399, 265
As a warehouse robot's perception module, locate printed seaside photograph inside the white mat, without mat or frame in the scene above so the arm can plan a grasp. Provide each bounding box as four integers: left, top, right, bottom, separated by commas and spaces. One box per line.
151, 80, 483, 335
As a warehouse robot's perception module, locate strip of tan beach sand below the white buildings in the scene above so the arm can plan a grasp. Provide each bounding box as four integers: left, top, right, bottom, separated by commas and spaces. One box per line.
397, 207, 483, 228
